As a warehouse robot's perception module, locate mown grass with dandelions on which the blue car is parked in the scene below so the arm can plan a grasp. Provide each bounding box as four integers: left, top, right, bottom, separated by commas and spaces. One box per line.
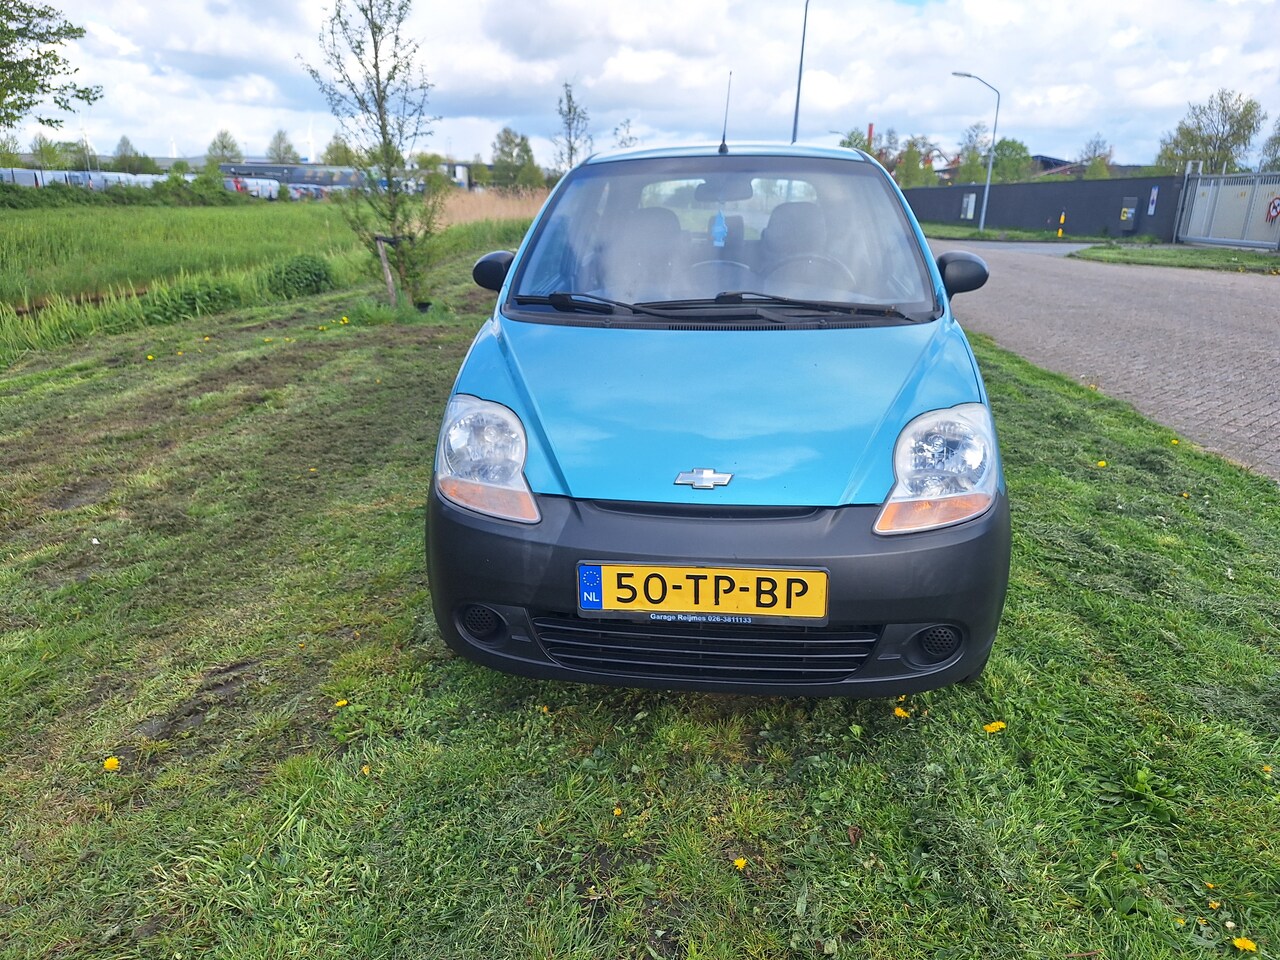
0, 232, 1280, 960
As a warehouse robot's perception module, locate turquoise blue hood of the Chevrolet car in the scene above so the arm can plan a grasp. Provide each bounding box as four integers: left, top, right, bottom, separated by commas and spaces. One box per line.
454, 316, 986, 507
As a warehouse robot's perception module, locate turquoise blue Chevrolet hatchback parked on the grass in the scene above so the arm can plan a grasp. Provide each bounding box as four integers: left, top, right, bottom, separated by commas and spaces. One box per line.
426, 145, 1010, 696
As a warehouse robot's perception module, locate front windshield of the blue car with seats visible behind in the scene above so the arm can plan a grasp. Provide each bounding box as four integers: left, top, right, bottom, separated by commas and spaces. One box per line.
512, 154, 934, 317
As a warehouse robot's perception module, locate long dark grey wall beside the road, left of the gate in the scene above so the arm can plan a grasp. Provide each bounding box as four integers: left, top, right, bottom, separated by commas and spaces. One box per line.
902, 177, 1183, 242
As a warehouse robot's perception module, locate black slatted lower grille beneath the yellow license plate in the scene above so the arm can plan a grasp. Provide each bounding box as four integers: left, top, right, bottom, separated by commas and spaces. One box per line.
534, 617, 879, 684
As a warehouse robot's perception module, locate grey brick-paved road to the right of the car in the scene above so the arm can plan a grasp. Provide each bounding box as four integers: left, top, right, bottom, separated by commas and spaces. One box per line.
932, 241, 1280, 480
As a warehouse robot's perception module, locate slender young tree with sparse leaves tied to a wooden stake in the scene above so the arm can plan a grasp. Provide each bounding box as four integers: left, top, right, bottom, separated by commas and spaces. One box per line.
305, 0, 445, 302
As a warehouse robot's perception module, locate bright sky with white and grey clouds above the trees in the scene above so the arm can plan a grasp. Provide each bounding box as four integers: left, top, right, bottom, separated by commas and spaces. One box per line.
19, 0, 1280, 165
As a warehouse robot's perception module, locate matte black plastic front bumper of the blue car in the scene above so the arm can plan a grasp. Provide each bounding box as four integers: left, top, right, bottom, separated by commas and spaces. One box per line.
426, 484, 1010, 696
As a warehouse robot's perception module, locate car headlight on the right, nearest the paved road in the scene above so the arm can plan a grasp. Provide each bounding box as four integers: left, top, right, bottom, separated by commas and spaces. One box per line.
874, 403, 1000, 534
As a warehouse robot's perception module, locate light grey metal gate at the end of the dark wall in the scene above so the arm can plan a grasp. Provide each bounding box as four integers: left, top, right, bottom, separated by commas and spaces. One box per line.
1178, 172, 1280, 251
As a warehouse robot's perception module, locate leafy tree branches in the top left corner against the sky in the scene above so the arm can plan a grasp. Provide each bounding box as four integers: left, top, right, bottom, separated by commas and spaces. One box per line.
0, 0, 102, 131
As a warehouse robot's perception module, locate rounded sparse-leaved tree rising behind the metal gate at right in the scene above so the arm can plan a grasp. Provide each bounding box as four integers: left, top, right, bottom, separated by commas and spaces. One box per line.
1156, 87, 1267, 174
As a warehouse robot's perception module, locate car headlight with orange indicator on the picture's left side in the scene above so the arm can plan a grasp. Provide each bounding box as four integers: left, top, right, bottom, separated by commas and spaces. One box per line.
435, 393, 541, 524
